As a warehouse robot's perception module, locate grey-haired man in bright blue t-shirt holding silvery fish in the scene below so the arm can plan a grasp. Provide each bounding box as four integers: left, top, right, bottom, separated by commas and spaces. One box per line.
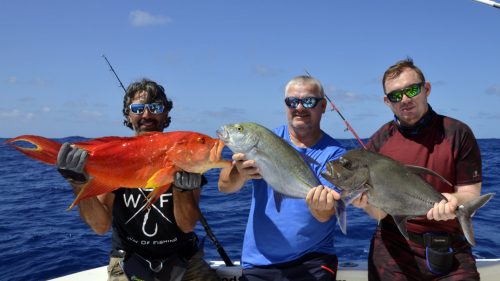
219, 76, 345, 280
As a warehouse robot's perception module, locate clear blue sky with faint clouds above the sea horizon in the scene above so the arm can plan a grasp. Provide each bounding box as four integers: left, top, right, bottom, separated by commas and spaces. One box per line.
0, 0, 500, 138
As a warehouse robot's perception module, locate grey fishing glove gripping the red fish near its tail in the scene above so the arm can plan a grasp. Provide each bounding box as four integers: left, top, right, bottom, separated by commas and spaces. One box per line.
56, 142, 89, 184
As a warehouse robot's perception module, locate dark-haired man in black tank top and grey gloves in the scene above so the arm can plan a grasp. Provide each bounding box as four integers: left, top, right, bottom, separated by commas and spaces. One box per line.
57, 79, 218, 281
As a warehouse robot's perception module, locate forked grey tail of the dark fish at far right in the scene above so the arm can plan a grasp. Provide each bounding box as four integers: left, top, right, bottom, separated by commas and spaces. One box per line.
456, 193, 495, 246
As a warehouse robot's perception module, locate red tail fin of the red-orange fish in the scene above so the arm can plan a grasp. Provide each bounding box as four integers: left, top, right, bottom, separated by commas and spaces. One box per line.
6, 135, 61, 165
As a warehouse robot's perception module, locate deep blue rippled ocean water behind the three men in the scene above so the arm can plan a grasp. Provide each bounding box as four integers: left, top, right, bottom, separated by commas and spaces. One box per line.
0, 137, 500, 280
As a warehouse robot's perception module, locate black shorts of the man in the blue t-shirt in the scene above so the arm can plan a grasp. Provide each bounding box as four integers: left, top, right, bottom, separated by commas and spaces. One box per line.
243, 253, 338, 281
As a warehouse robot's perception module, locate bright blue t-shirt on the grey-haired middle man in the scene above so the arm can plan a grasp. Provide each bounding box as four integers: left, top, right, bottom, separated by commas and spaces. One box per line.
241, 125, 346, 268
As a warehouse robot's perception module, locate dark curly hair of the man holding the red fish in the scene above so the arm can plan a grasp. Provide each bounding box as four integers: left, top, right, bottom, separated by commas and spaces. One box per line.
122, 78, 174, 129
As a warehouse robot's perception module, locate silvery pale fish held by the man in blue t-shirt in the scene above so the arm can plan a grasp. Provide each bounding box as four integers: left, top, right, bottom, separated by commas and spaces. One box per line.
217, 123, 346, 234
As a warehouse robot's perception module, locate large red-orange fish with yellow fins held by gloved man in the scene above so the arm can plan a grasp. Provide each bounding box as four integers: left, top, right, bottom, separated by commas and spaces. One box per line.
7, 131, 231, 209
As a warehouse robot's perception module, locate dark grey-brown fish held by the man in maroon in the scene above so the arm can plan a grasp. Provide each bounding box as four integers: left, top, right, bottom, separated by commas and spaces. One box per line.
322, 149, 495, 246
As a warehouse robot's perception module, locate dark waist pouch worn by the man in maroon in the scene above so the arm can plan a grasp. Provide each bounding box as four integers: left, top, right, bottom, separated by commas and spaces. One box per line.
423, 233, 455, 275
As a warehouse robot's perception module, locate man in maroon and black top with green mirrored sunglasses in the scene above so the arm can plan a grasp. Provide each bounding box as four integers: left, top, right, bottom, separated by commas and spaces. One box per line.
353, 58, 482, 280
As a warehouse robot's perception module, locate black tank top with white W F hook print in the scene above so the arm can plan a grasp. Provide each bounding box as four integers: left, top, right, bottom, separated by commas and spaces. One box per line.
111, 188, 197, 259
